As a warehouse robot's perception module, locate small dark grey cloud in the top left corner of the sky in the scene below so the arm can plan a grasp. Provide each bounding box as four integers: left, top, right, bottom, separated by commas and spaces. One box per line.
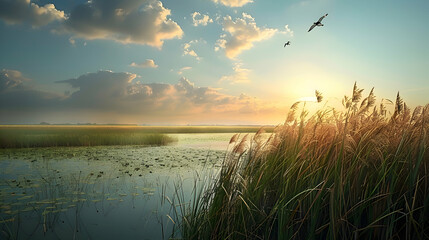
0, 0, 66, 27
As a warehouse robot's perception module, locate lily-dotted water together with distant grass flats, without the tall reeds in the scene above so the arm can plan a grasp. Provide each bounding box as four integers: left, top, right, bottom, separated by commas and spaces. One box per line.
0, 125, 273, 239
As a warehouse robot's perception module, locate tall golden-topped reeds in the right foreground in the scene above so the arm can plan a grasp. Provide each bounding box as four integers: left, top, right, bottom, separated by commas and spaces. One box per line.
179, 84, 429, 239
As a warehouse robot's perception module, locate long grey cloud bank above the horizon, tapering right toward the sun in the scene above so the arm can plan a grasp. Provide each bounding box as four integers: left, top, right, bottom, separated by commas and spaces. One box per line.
54, 71, 274, 119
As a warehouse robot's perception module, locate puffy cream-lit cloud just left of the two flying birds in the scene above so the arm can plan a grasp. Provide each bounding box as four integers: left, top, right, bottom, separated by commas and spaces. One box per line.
215, 13, 277, 58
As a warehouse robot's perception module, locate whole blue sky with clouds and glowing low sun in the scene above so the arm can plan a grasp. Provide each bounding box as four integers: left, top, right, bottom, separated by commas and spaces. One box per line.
0, 0, 429, 125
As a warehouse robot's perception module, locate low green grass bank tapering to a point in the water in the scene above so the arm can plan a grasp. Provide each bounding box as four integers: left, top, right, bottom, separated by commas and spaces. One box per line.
0, 126, 175, 148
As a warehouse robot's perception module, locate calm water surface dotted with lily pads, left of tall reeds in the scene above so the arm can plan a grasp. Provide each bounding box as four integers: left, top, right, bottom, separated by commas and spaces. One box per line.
0, 133, 237, 239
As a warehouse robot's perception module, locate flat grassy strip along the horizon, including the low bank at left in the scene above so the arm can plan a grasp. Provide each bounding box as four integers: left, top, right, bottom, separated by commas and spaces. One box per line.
0, 125, 273, 148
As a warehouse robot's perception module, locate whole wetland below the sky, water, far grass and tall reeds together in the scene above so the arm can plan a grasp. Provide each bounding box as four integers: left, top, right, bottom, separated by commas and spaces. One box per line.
0, 84, 429, 239
